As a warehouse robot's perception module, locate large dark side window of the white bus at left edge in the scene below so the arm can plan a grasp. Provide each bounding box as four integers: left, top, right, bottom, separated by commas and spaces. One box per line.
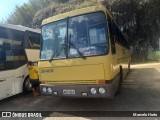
0, 27, 27, 70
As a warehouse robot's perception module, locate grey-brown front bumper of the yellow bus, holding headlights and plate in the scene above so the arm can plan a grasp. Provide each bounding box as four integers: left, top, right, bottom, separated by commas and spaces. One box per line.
40, 83, 114, 98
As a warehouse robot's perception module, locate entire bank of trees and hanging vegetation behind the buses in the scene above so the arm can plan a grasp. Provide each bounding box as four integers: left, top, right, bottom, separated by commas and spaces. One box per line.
1, 0, 160, 62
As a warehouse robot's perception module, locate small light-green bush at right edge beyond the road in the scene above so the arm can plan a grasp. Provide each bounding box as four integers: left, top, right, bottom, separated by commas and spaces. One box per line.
147, 51, 160, 61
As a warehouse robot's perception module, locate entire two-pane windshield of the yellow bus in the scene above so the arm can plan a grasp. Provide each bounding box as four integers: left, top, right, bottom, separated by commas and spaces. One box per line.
41, 12, 108, 60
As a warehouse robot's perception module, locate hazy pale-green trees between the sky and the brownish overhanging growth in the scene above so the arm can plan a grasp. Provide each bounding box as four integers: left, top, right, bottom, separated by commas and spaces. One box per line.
6, 0, 59, 27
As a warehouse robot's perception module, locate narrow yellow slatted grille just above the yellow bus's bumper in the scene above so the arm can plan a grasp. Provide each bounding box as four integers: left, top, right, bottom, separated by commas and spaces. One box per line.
46, 80, 98, 85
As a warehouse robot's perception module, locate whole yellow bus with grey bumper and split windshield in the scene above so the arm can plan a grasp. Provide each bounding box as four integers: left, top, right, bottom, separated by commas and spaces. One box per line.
38, 5, 131, 98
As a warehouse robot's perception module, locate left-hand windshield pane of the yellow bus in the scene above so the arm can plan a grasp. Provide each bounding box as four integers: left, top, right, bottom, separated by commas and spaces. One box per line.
41, 19, 67, 60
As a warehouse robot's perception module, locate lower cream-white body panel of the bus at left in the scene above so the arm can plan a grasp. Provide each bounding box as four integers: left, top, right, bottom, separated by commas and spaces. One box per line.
0, 65, 28, 100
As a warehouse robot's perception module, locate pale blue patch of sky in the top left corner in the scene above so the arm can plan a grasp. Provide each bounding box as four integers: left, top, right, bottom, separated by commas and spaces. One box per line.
0, 0, 28, 20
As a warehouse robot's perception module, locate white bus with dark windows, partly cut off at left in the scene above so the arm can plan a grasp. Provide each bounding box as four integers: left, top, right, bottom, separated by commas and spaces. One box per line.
0, 24, 40, 100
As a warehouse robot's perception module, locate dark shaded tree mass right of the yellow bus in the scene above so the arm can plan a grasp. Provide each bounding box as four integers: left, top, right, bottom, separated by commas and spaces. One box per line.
110, 0, 160, 60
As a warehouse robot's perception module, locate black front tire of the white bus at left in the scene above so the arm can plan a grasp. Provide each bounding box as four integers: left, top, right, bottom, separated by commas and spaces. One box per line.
23, 76, 32, 94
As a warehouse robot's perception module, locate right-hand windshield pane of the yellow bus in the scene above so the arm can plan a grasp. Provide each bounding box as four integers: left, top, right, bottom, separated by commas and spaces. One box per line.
68, 12, 108, 57
